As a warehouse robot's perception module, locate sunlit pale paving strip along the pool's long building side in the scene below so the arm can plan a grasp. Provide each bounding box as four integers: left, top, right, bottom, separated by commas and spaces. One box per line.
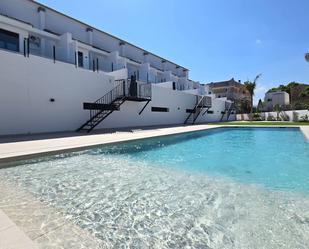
0, 125, 221, 164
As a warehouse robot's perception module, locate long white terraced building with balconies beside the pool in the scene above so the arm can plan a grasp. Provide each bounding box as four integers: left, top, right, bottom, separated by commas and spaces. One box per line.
0, 0, 235, 135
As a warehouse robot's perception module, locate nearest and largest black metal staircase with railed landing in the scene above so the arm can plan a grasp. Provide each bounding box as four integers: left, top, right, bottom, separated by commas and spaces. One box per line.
76, 79, 151, 132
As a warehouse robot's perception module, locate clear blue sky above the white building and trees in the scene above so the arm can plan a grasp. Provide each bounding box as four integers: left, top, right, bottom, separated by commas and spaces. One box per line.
40, 0, 309, 101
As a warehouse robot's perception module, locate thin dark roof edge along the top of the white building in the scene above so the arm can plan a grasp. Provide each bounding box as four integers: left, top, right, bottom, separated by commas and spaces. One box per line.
28, 0, 189, 70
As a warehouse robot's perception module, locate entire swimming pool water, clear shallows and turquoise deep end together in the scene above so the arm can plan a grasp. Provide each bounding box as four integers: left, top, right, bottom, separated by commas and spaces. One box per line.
0, 128, 309, 248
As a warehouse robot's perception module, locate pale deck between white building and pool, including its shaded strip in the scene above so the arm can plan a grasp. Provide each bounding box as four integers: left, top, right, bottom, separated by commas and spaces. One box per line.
0, 125, 221, 163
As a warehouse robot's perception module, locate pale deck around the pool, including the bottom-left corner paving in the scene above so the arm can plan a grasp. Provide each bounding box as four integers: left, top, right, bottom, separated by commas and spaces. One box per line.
0, 125, 309, 249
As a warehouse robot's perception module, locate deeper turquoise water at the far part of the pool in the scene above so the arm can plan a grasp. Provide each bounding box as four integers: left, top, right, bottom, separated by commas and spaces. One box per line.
89, 128, 309, 194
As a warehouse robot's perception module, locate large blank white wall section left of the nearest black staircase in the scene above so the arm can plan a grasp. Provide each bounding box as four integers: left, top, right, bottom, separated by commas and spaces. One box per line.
0, 51, 114, 135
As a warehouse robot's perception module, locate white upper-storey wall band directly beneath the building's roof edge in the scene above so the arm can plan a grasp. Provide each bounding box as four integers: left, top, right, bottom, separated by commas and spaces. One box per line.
0, 0, 188, 78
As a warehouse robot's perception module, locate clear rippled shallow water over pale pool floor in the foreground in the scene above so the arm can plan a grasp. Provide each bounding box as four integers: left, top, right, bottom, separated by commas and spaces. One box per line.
1, 154, 309, 248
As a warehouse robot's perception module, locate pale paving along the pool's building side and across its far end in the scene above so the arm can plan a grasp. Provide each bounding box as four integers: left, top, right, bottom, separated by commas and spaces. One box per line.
0, 124, 309, 165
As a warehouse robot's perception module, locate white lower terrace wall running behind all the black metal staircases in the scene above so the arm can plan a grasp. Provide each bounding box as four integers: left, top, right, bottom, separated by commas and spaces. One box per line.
0, 51, 229, 135
